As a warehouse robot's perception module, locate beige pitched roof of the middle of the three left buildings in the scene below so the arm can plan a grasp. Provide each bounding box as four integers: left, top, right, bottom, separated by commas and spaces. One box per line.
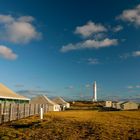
31, 95, 57, 105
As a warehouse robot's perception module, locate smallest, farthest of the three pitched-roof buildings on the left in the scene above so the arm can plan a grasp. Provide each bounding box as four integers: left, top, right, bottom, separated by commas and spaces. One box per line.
52, 97, 70, 108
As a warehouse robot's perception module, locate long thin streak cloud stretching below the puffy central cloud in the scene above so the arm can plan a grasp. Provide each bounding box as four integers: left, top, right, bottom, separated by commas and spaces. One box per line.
60, 38, 118, 52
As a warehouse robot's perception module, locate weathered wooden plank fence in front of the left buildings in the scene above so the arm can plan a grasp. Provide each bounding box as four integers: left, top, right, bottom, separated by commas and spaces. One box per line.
0, 103, 48, 124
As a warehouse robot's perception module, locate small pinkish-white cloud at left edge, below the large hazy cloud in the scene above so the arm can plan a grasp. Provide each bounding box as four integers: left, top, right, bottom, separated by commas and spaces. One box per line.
0, 45, 17, 60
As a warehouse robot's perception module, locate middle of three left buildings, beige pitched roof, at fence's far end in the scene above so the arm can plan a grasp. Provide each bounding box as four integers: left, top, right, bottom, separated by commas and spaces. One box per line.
30, 95, 61, 111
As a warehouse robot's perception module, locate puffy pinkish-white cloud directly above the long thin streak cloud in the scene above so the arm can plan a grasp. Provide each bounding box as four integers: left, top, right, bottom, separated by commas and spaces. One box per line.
75, 21, 107, 37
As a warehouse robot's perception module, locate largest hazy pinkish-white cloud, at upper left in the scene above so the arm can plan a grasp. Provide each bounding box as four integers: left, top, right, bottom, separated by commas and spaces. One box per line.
0, 15, 41, 43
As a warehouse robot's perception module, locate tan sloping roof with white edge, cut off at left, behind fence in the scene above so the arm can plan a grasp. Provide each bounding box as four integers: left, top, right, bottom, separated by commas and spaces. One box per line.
0, 83, 30, 100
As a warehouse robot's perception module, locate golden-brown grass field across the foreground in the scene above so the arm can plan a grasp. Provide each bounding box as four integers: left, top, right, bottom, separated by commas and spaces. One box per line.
0, 110, 140, 140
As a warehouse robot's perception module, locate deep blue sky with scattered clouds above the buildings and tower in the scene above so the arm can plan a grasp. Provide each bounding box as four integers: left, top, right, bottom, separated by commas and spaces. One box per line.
0, 0, 140, 100
